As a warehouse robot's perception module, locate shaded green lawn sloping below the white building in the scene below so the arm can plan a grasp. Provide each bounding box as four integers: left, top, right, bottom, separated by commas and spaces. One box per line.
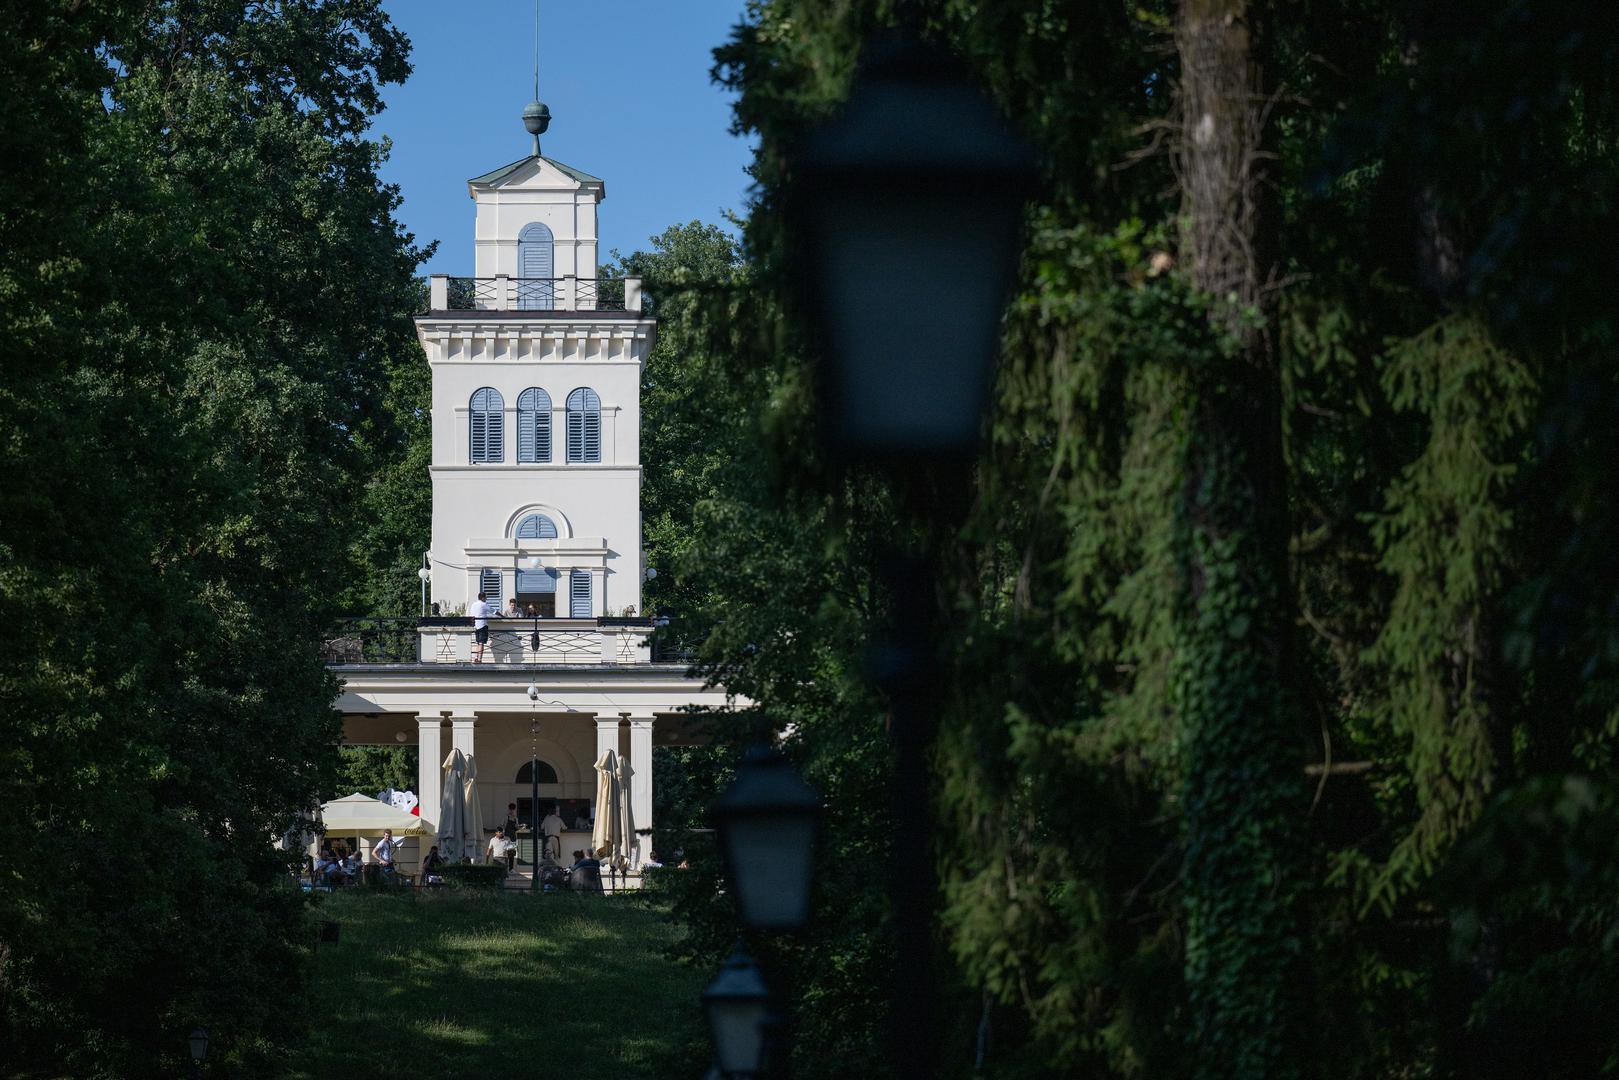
291, 891, 706, 1080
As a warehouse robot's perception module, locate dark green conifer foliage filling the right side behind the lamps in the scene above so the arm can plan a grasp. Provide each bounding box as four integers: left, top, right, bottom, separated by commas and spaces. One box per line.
663, 0, 1619, 1077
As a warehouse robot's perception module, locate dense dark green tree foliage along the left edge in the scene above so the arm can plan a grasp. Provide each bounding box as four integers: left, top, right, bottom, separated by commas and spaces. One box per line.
0, 0, 419, 1075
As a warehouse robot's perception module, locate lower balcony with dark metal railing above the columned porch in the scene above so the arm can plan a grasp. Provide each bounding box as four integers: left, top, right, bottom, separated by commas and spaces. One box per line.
321, 615, 690, 667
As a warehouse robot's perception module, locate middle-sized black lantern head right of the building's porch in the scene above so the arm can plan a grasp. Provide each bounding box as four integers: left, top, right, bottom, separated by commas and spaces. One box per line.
714, 746, 821, 929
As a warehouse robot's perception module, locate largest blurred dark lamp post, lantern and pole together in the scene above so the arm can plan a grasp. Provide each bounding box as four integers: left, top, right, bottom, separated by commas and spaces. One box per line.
787, 25, 1036, 1077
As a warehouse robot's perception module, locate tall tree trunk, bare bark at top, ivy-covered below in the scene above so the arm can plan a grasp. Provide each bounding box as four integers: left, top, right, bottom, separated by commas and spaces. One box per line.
1174, 0, 1310, 1080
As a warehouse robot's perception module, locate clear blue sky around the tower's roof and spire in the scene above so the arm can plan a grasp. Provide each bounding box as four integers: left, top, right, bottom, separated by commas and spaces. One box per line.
374, 0, 750, 275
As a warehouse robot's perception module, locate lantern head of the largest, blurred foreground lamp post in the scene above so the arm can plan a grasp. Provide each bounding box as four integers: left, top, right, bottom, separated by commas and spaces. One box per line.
788, 36, 1036, 458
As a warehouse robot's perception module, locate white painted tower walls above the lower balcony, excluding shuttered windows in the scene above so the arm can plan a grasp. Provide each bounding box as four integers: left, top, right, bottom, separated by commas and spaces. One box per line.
416, 146, 656, 615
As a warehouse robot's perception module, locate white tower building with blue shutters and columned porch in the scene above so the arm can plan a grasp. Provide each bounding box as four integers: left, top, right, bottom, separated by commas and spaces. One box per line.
327, 102, 729, 861
